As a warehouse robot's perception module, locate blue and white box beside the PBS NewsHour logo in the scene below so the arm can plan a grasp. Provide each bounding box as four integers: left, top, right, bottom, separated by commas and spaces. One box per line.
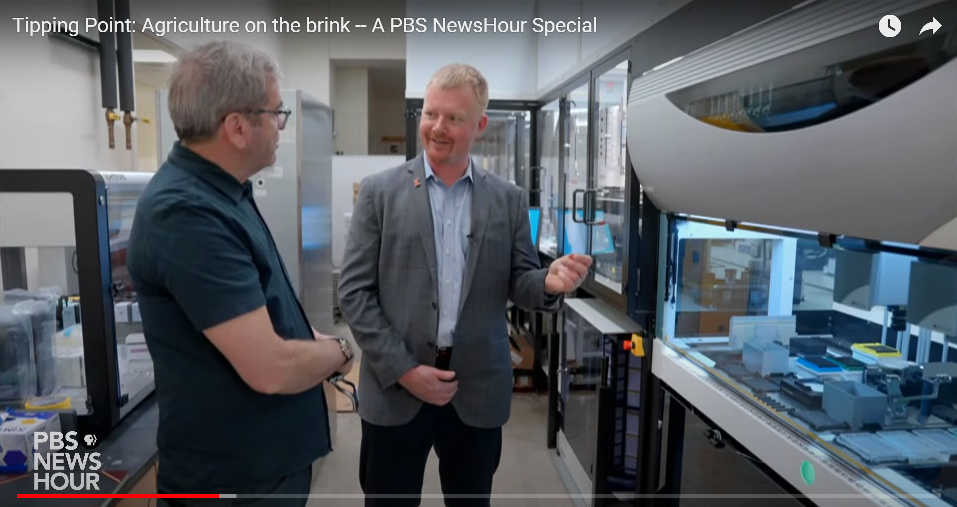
0, 411, 61, 474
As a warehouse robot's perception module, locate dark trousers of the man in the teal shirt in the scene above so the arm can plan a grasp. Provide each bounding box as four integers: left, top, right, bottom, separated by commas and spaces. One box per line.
156, 465, 312, 507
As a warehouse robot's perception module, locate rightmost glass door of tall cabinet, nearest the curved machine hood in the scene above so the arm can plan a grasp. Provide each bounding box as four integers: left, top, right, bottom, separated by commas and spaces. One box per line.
589, 60, 628, 294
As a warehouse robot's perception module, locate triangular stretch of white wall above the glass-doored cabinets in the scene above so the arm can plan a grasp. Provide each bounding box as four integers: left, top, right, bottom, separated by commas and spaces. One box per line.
534, 0, 692, 98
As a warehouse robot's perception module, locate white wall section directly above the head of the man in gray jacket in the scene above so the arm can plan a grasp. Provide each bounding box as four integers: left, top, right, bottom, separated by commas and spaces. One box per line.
405, 0, 536, 100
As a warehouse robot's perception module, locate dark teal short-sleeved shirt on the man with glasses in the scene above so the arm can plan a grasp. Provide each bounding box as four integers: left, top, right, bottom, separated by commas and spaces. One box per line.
127, 143, 331, 493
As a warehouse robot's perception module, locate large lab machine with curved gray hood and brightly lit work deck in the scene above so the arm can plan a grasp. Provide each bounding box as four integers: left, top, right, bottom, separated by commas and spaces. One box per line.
627, 0, 957, 507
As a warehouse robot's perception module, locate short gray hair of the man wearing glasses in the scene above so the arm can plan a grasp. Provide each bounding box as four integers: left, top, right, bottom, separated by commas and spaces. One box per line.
168, 41, 281, 141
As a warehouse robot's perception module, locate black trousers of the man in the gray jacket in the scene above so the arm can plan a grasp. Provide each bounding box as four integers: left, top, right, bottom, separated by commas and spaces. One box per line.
359, 350, 502, 507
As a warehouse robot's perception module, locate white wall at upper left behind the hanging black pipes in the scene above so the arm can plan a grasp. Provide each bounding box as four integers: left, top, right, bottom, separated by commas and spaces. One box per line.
0, 0, 136, 171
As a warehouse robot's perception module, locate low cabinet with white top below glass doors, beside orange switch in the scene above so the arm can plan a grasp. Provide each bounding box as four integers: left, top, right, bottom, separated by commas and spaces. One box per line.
557, 298, 651, 507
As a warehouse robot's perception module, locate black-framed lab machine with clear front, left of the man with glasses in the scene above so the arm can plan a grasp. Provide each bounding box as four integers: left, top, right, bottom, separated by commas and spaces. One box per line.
0, 169, 154, 439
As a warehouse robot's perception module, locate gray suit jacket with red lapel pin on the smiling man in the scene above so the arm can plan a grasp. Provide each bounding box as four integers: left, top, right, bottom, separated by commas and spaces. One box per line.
338, 154, 562, 428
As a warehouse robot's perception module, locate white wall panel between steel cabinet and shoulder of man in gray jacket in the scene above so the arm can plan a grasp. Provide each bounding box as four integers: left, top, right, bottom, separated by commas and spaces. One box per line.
332, 155, 405, 269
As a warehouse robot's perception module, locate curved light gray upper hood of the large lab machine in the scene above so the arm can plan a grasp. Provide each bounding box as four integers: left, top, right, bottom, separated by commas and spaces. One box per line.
627, 0, 957, 250
